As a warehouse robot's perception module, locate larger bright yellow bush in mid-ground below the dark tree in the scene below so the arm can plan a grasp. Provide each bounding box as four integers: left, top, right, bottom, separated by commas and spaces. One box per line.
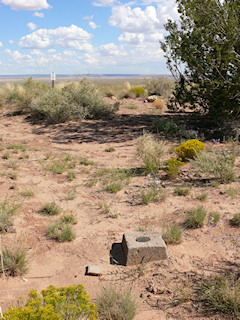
174, 139, 205, 161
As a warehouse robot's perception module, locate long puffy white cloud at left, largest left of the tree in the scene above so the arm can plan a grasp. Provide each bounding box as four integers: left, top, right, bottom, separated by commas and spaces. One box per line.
18, 25, 92, 52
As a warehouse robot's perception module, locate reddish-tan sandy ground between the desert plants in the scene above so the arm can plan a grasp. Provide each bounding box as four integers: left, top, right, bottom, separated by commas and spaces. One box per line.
0, 100, 240, 320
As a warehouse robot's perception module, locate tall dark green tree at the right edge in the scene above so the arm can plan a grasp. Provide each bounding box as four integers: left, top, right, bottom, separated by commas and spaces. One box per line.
161, 0, 240, 120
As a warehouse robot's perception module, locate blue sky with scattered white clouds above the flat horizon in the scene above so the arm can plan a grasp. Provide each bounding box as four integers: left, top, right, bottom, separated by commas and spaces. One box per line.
0, 0, 178, 75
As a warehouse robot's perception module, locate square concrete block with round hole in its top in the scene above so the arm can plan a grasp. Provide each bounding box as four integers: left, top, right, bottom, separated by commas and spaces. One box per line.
122, 231, 167, 266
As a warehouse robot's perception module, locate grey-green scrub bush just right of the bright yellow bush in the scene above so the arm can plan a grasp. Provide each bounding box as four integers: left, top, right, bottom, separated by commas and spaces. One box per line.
191, 150, 236, 183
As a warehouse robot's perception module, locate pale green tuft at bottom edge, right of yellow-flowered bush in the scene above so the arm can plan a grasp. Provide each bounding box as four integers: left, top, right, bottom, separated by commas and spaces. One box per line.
96, 287, 137, 320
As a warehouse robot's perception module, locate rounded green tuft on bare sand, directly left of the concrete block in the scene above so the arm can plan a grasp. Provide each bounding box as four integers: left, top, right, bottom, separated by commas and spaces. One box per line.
46, 221, 76, 242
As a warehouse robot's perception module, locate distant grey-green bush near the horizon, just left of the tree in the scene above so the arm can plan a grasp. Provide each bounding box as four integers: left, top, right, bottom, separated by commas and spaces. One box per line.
144, 77, 174, 97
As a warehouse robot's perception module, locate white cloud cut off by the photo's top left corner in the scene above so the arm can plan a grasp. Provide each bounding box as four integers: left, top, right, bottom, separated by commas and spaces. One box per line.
1, 0, 51, 10
